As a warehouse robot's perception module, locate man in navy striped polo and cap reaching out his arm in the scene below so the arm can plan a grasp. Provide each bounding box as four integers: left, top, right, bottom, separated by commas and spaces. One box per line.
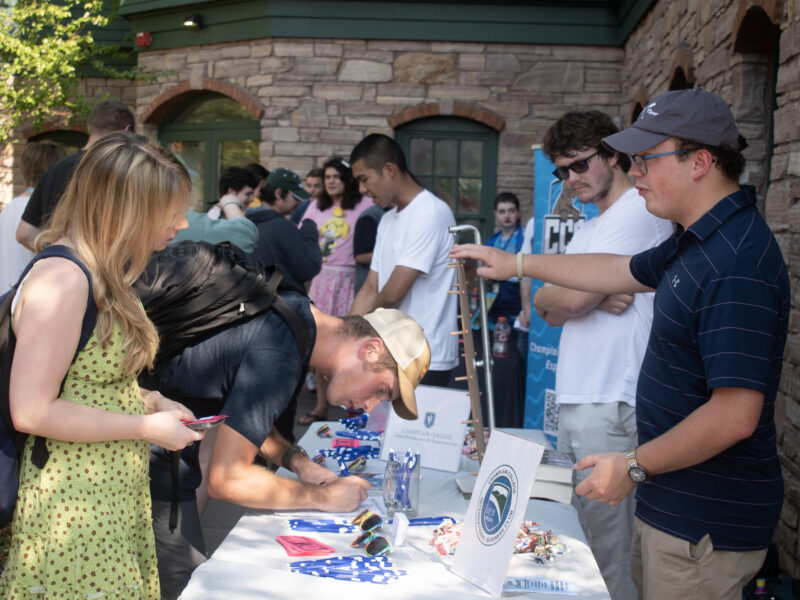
453, 89, 789, 600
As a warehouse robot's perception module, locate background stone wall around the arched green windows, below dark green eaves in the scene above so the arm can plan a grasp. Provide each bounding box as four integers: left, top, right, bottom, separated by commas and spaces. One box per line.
136, 38, 622, 218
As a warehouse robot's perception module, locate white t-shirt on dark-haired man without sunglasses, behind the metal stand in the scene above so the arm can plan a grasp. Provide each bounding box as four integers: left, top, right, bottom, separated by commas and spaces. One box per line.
370, 190, 458, 371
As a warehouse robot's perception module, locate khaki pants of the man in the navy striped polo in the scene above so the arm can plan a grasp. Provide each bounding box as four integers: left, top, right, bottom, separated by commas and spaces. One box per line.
631, 518, 767, 600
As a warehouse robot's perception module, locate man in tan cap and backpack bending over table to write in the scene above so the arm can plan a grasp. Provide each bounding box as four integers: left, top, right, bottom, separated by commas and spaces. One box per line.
136, 264, 430, 599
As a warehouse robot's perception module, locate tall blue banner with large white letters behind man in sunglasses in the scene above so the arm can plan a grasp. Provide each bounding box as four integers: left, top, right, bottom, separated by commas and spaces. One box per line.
524, 150, 597, 445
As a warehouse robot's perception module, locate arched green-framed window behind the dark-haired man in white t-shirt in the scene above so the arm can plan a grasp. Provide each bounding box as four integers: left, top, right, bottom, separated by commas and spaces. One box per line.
395, 117, 498, 241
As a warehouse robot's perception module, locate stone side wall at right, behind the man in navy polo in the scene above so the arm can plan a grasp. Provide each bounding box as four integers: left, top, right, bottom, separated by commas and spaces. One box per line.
623, 0, 800, 577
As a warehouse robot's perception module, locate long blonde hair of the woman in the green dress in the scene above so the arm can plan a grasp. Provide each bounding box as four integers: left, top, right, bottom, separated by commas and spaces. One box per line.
36, 131, 191, 374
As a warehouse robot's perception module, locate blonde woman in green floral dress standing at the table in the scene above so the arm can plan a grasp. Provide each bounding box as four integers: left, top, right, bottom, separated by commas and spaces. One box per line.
0, 131, 201, 600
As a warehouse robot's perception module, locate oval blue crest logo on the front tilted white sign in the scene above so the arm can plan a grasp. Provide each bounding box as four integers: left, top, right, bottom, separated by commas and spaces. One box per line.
475, 465, 518, 546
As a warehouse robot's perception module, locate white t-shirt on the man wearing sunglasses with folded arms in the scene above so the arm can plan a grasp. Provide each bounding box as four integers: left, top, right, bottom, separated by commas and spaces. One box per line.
556, 188, 672, 406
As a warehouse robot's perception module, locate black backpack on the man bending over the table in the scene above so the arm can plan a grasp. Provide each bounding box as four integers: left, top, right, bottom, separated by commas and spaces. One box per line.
134, 241, 309, 360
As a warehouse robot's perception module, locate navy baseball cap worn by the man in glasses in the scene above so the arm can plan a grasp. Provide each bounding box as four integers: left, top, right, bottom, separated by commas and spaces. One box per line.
603, 88, 740, 154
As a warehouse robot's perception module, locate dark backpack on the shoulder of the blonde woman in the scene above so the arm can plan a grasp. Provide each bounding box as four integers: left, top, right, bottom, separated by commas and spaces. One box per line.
0, 246, 97, 527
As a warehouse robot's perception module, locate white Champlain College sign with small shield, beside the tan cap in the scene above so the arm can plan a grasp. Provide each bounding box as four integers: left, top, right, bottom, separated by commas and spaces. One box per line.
381, 385, 470, 473
